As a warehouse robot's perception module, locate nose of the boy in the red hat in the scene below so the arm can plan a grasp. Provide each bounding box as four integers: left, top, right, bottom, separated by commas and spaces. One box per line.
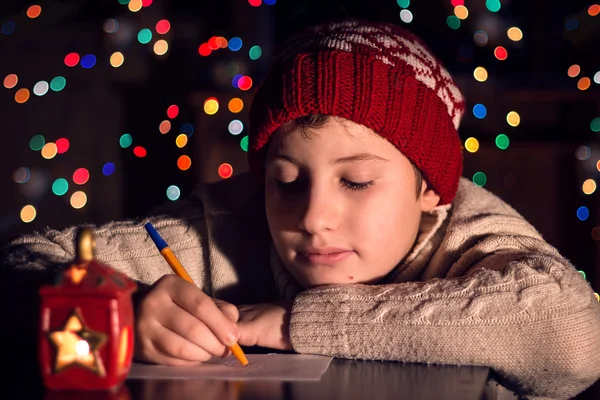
298, 189, 340, 235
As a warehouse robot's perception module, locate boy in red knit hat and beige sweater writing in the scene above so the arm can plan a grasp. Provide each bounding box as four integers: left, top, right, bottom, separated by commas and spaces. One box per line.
1, 20, 600, 399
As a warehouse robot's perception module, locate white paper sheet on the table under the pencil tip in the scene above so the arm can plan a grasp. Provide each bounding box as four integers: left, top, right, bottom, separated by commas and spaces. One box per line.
128, 354, 332, 381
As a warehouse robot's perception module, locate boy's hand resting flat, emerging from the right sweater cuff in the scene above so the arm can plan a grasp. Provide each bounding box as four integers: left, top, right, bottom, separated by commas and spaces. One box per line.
238, 301, 293, 350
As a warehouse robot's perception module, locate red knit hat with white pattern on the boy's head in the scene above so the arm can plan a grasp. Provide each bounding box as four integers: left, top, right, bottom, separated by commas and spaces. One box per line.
248, 20, 465, 204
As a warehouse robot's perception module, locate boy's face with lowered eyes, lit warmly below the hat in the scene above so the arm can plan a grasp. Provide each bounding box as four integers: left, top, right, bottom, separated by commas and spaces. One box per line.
265, 118, 439, 288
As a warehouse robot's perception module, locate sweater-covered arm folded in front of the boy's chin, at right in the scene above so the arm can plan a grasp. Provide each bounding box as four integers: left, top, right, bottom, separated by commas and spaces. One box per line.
290, 236, 600, 399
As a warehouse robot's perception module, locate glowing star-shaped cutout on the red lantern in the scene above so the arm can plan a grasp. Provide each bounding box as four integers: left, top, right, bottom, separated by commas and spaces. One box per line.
48, 309, 107, 376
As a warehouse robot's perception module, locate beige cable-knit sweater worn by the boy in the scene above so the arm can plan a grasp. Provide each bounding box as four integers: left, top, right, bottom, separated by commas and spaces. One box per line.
5, 174, 600, 399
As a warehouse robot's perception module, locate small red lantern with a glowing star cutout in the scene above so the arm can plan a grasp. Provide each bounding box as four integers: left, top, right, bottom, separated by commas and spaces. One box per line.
38, 229, 136, 390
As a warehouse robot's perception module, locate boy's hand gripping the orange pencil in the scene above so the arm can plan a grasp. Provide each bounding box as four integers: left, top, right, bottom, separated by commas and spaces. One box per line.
134, 275, 239, 365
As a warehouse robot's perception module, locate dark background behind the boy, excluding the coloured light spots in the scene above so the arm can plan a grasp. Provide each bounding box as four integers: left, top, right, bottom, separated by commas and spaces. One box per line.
0, 0, 600, 398
